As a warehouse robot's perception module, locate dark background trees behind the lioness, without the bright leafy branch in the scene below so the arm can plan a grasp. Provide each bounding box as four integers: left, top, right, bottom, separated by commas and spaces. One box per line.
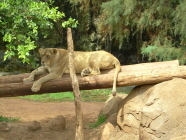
0, 0, 186, 72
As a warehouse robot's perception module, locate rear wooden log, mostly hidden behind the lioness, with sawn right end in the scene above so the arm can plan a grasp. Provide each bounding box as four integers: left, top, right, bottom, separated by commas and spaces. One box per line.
0, 60, 179, 84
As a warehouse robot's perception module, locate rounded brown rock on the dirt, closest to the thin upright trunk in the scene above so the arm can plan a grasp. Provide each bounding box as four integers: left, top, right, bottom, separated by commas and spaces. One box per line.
49, 115, 66, 131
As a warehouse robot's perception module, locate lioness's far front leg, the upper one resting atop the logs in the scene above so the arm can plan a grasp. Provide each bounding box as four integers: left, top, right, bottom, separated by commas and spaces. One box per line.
23, 66, 47, 83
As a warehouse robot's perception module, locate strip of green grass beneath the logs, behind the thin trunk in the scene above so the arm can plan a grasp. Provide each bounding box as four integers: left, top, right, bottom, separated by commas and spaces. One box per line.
16, 89, 116, 102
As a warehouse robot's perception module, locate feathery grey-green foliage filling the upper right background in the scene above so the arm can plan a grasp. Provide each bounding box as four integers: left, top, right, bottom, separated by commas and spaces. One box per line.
100, 0, 186, 64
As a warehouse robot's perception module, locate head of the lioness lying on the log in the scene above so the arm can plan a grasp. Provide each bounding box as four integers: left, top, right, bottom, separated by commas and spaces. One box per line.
39, 48, 57, 66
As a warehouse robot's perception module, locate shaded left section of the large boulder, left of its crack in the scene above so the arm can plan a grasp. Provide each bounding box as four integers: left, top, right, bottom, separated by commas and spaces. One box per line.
117, 85, 153, 135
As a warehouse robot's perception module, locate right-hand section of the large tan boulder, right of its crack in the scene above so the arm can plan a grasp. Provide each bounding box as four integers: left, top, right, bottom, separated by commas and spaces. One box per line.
139, 78, 186, 140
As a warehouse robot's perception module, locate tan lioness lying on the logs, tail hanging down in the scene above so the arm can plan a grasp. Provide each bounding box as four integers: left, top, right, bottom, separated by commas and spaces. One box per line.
23, 48, 121, 96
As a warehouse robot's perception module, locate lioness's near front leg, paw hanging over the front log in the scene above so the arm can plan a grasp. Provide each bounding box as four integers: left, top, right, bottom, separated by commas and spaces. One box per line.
31, 73, 60, 92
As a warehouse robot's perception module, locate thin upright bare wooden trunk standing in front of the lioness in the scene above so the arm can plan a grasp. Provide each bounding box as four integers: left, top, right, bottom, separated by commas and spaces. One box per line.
67, 28, 84, 140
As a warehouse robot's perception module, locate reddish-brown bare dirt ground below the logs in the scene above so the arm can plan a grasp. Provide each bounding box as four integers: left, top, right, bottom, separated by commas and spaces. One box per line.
0, 98, 104, 140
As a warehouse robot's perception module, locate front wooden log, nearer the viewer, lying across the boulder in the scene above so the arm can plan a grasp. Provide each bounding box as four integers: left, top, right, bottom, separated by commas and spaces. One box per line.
0, 66, 186, 97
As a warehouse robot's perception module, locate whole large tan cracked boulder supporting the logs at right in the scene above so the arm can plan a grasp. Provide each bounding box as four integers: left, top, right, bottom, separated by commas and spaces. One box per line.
117, 78, 186, 140
